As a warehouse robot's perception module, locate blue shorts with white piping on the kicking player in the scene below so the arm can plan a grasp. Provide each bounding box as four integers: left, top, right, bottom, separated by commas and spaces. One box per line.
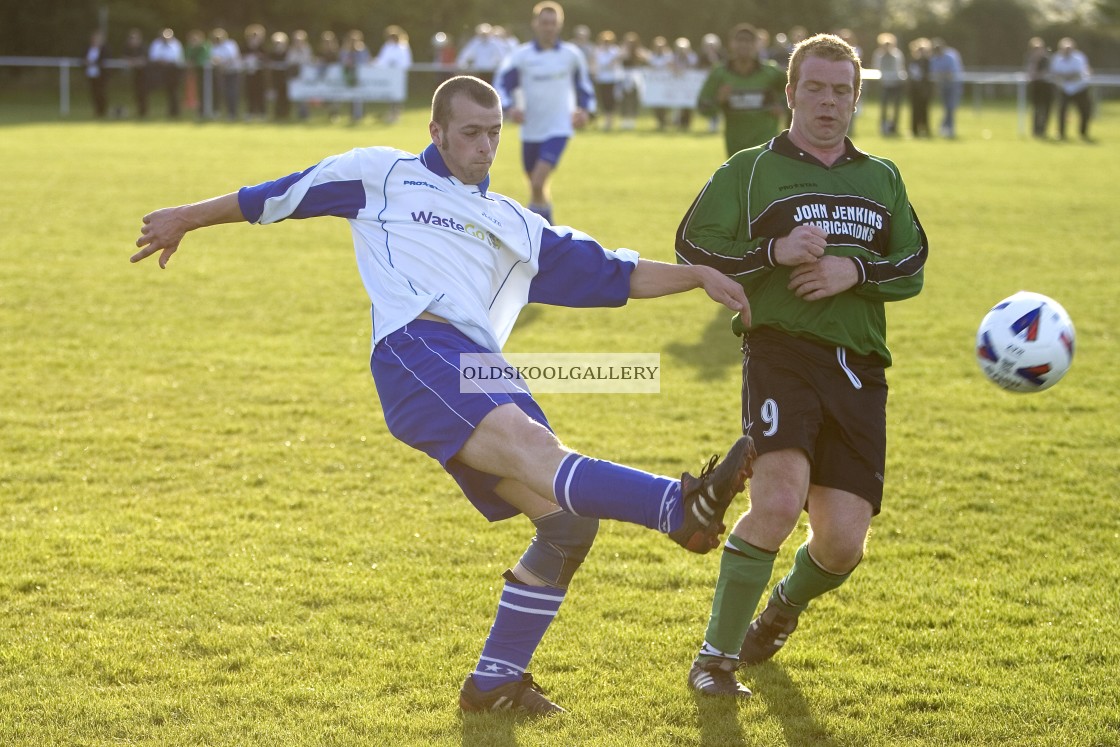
370, 319, 552, 521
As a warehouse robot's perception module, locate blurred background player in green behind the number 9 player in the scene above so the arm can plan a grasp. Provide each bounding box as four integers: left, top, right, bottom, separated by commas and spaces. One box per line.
697, 24, 785, 156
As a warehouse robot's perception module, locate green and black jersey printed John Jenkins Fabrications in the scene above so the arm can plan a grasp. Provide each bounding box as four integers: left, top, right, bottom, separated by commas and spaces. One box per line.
676, 133, 928, 365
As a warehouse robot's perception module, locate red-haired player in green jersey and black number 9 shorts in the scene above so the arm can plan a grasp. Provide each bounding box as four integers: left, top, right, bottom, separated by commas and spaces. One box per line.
676, 35, 927, 695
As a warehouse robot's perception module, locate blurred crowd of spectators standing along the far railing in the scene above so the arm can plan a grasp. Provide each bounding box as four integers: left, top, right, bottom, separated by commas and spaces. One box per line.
83, 22, 1093, 140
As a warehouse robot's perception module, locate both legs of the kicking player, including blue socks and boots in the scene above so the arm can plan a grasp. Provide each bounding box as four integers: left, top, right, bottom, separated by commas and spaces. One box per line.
456, 404, 754, 716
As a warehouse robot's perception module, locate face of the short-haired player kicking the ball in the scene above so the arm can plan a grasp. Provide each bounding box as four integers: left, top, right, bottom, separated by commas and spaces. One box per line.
428, 95, 502, 184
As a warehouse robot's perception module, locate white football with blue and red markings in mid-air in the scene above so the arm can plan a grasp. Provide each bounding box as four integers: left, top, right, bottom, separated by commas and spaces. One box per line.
977, 290, 1074, 392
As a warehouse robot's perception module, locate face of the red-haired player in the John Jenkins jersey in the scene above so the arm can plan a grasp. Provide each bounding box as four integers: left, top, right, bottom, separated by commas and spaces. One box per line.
785, 56, 858, 149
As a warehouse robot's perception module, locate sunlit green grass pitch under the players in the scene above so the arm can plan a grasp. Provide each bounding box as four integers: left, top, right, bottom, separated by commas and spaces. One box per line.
0, 104, 1120, 747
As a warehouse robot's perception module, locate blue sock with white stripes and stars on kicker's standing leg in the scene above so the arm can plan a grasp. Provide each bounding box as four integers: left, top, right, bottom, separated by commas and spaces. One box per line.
473, 581, 567, 691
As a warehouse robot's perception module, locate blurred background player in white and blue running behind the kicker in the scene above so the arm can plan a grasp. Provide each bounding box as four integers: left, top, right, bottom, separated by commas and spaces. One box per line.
494, 2, 595, 223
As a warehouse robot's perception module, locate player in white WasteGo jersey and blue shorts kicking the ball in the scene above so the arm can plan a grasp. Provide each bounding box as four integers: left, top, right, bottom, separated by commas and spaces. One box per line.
132, 76, 754, 715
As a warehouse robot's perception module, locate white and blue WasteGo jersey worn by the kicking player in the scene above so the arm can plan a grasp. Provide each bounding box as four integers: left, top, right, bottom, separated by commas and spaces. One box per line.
237, 146, 637, 351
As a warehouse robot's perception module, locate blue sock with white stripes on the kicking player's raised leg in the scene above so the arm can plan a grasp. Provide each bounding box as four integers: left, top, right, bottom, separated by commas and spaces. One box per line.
552, 452, 684, 533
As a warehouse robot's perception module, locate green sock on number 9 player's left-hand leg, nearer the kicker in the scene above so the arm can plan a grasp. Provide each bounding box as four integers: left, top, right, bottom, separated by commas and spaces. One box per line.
703, 534, 777, 656
